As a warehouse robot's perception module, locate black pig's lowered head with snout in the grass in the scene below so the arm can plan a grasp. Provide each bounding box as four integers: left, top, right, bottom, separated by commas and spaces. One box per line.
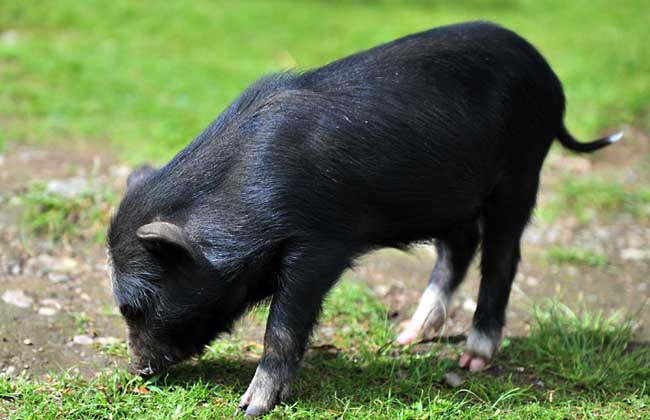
107, 167, 254, 375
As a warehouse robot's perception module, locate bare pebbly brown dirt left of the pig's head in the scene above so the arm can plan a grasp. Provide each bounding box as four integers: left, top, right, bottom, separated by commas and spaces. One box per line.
0, 146, 124, 376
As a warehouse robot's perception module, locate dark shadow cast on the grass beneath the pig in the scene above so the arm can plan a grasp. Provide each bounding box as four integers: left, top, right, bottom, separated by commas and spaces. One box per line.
165, 331, 650, 409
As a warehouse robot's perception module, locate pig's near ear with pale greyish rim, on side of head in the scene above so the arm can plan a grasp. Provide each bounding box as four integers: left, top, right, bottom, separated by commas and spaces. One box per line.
136, 222, 199, 262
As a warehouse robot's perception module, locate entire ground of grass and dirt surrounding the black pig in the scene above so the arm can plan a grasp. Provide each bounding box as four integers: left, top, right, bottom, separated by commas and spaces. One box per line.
0, 0, 650, 419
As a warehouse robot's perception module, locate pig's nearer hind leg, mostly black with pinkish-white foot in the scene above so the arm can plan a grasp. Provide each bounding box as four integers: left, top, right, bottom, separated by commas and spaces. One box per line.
459, 174, 539, 371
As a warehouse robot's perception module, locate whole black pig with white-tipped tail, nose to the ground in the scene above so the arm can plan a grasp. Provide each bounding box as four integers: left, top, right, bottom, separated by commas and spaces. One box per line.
108, 22, 621, 416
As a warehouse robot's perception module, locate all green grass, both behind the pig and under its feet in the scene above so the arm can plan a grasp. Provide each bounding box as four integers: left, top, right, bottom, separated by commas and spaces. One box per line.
0, 0, 650, 420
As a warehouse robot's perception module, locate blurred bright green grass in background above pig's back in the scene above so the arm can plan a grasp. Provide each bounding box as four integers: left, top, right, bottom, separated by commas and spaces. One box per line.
0, 0, 650, 162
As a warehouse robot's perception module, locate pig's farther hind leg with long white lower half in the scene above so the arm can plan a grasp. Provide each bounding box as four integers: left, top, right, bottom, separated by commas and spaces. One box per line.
397, 221, 480, 345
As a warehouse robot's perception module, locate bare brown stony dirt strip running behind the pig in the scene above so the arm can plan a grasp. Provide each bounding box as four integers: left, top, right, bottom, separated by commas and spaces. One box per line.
0, 130, 650, 376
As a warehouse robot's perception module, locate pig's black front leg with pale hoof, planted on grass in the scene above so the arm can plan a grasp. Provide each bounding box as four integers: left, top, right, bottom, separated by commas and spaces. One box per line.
239, 246, 345, 417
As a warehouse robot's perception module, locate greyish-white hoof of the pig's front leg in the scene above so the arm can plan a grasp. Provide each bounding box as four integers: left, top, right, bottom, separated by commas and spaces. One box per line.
237, 366, 289, 417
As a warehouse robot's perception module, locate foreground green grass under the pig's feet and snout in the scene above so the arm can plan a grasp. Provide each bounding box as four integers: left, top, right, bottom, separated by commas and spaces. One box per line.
0, 281, 650, 419
